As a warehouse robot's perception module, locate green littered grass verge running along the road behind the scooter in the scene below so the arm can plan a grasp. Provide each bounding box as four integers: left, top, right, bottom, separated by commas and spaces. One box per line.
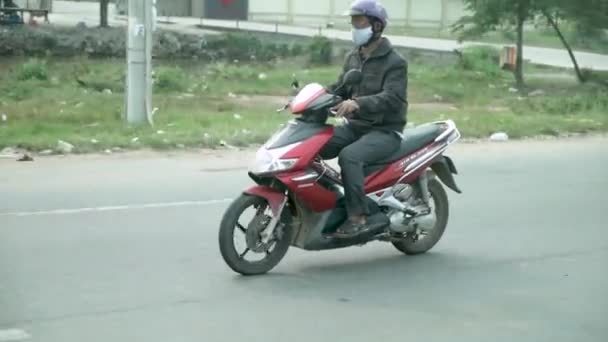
0, 56, 608, 152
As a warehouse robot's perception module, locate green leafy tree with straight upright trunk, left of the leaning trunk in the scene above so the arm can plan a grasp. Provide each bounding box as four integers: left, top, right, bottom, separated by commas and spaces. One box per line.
454, 0, 535, 89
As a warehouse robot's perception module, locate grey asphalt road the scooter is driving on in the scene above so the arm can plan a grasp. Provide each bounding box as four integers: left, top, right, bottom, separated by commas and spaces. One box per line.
0, 139, 608, 342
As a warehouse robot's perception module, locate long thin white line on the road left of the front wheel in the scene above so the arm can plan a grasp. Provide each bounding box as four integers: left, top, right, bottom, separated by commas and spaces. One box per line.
0, 198, 232, 218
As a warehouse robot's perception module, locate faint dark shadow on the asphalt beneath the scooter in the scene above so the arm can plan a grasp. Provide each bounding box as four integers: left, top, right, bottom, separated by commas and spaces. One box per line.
227, 253, 490, 301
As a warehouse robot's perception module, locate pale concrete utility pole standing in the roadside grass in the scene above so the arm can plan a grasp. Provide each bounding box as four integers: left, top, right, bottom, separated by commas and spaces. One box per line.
125, 0, 156, 124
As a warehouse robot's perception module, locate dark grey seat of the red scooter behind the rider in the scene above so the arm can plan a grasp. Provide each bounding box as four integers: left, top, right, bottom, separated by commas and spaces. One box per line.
364, 124, 443, 175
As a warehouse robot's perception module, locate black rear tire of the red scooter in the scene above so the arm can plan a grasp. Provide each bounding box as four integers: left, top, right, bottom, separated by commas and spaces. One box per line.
393, 178, 450, 255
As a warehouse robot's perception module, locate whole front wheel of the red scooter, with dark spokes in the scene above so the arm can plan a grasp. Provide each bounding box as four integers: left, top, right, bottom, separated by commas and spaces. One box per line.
219, 194, 293, 276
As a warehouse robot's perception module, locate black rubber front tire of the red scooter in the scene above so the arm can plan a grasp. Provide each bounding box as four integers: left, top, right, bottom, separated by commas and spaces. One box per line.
219, 194, 293, 276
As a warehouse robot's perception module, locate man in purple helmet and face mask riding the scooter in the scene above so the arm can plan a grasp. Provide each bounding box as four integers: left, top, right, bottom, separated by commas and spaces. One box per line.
321, 0, 407, 238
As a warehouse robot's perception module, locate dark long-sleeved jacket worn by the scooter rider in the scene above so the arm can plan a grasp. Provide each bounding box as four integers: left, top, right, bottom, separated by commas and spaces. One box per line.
329, 38, 408, 132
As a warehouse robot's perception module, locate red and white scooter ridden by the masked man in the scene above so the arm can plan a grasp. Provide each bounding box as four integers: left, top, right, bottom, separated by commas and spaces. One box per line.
219, 70, 461, 275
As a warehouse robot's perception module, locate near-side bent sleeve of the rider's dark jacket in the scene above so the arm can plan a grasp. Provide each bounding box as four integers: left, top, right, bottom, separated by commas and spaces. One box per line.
354, 62, 407, 121
